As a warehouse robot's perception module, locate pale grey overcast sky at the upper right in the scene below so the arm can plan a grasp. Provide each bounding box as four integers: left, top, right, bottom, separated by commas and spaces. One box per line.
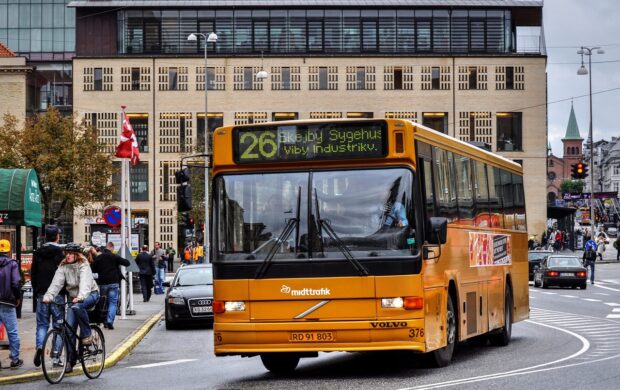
543, 0, 620, 157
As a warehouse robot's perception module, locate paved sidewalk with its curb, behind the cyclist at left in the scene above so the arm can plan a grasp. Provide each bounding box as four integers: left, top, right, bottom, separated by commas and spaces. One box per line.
0, 282, 173, 385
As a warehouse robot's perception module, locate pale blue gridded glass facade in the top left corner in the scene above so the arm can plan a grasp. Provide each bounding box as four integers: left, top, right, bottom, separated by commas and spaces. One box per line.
0, 0, 75, 60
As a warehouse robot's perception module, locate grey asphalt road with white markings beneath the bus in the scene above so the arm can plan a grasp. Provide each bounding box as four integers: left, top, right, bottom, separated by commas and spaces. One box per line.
13, 264, 620, 389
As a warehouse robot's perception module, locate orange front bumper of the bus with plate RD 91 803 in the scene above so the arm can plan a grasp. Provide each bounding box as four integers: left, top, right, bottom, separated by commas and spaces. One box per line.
213, 319, 426, 356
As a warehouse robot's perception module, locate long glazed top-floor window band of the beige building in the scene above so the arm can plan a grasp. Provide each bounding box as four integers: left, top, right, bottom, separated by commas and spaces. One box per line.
116, 8, 516, 54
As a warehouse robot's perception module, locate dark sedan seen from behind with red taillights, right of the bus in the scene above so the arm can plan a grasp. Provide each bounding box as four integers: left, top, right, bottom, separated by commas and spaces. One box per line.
534, 255, 588, 290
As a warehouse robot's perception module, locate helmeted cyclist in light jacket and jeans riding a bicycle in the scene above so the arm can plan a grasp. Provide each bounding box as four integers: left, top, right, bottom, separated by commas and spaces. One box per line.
43, 243, 99, 372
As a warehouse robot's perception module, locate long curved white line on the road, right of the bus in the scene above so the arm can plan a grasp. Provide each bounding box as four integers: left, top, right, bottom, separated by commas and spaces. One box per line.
400, 320, 590, 390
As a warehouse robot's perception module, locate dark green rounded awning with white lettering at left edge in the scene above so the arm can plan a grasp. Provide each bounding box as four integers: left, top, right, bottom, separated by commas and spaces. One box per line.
0, 169, 42, 227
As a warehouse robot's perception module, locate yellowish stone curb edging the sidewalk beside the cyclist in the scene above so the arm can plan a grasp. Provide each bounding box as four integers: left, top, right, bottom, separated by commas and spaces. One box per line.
0, 310, 164, 386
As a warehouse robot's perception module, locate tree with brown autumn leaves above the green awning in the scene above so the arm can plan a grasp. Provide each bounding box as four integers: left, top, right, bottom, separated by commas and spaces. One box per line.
0, 107, 114, 225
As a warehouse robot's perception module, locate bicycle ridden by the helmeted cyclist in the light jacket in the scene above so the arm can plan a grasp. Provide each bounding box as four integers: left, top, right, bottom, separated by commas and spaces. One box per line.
41, 302, 105, 384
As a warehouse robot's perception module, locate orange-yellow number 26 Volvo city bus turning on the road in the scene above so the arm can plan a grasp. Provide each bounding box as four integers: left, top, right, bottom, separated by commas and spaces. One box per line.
211, 119, 529, 373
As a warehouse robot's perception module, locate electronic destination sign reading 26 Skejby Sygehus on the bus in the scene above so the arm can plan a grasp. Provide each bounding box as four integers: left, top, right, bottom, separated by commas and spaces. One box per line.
233, 121, 387, 163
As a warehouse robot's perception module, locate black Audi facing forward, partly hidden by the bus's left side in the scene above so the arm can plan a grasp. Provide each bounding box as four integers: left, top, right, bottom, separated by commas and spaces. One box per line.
165, 264, 213, 329
